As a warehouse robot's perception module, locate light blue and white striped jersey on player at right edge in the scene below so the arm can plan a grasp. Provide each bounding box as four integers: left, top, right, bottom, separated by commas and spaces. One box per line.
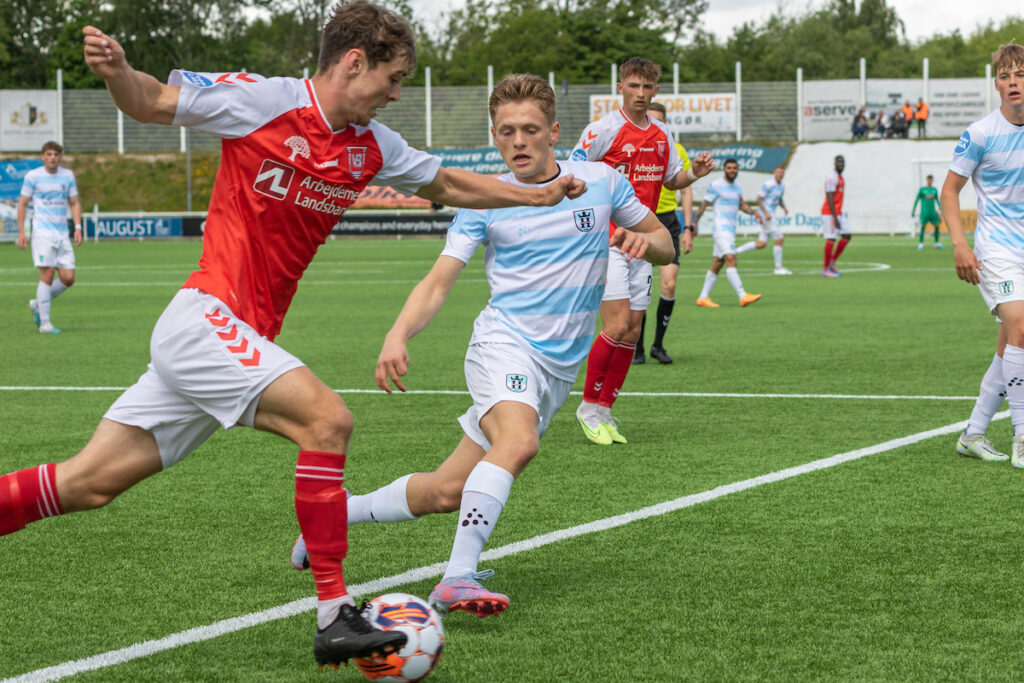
949, 110, 1024, 261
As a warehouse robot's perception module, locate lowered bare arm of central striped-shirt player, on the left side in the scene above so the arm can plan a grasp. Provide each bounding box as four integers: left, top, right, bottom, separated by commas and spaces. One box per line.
377, 255, 466, 393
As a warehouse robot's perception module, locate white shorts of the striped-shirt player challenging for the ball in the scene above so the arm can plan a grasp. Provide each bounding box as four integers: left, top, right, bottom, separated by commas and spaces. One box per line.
459, 342, 572, 451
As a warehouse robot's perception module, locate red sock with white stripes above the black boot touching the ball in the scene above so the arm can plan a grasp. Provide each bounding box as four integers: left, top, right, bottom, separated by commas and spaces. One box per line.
295, 451, 348, 600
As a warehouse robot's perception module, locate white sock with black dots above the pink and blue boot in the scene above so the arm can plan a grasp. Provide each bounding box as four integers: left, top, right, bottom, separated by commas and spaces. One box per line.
444, 461, 515, 579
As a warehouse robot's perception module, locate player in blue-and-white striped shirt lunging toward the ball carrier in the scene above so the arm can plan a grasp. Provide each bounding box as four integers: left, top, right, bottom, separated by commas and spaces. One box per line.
292, 74, 672, 616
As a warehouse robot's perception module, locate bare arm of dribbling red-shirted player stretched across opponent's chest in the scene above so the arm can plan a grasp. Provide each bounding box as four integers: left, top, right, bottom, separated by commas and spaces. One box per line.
416, 167, 587, 209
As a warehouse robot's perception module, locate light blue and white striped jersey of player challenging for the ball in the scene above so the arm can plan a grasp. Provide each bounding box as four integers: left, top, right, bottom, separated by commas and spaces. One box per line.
441, 161, 649, 382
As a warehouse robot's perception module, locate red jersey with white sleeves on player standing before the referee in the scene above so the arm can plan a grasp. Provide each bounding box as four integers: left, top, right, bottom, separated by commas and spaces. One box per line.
570, 110, 683, 227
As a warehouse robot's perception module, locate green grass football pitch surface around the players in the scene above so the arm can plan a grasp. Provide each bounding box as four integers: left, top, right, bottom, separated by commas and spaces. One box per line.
0, 237, 1024, 683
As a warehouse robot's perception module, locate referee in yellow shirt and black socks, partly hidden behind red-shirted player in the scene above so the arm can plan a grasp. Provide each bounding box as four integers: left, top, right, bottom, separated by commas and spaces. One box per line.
633, 102, 696, 366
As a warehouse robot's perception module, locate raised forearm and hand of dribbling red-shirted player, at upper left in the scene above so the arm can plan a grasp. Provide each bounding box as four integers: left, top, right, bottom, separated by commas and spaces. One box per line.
82, 26, 181, 125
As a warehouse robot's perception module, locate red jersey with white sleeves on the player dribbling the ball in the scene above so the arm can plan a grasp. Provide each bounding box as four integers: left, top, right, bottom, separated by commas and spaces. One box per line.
168, 71, 440, 339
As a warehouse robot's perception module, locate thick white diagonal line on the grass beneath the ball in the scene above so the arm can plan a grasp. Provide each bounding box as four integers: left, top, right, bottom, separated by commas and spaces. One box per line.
0, 411, 1010, 683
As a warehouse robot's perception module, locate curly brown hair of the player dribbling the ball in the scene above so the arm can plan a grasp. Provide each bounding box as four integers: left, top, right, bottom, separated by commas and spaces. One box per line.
317, 0, 416, 72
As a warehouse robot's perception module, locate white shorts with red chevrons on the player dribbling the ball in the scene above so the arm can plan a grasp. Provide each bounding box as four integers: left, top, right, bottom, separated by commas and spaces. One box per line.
103, 289, 303, 469
